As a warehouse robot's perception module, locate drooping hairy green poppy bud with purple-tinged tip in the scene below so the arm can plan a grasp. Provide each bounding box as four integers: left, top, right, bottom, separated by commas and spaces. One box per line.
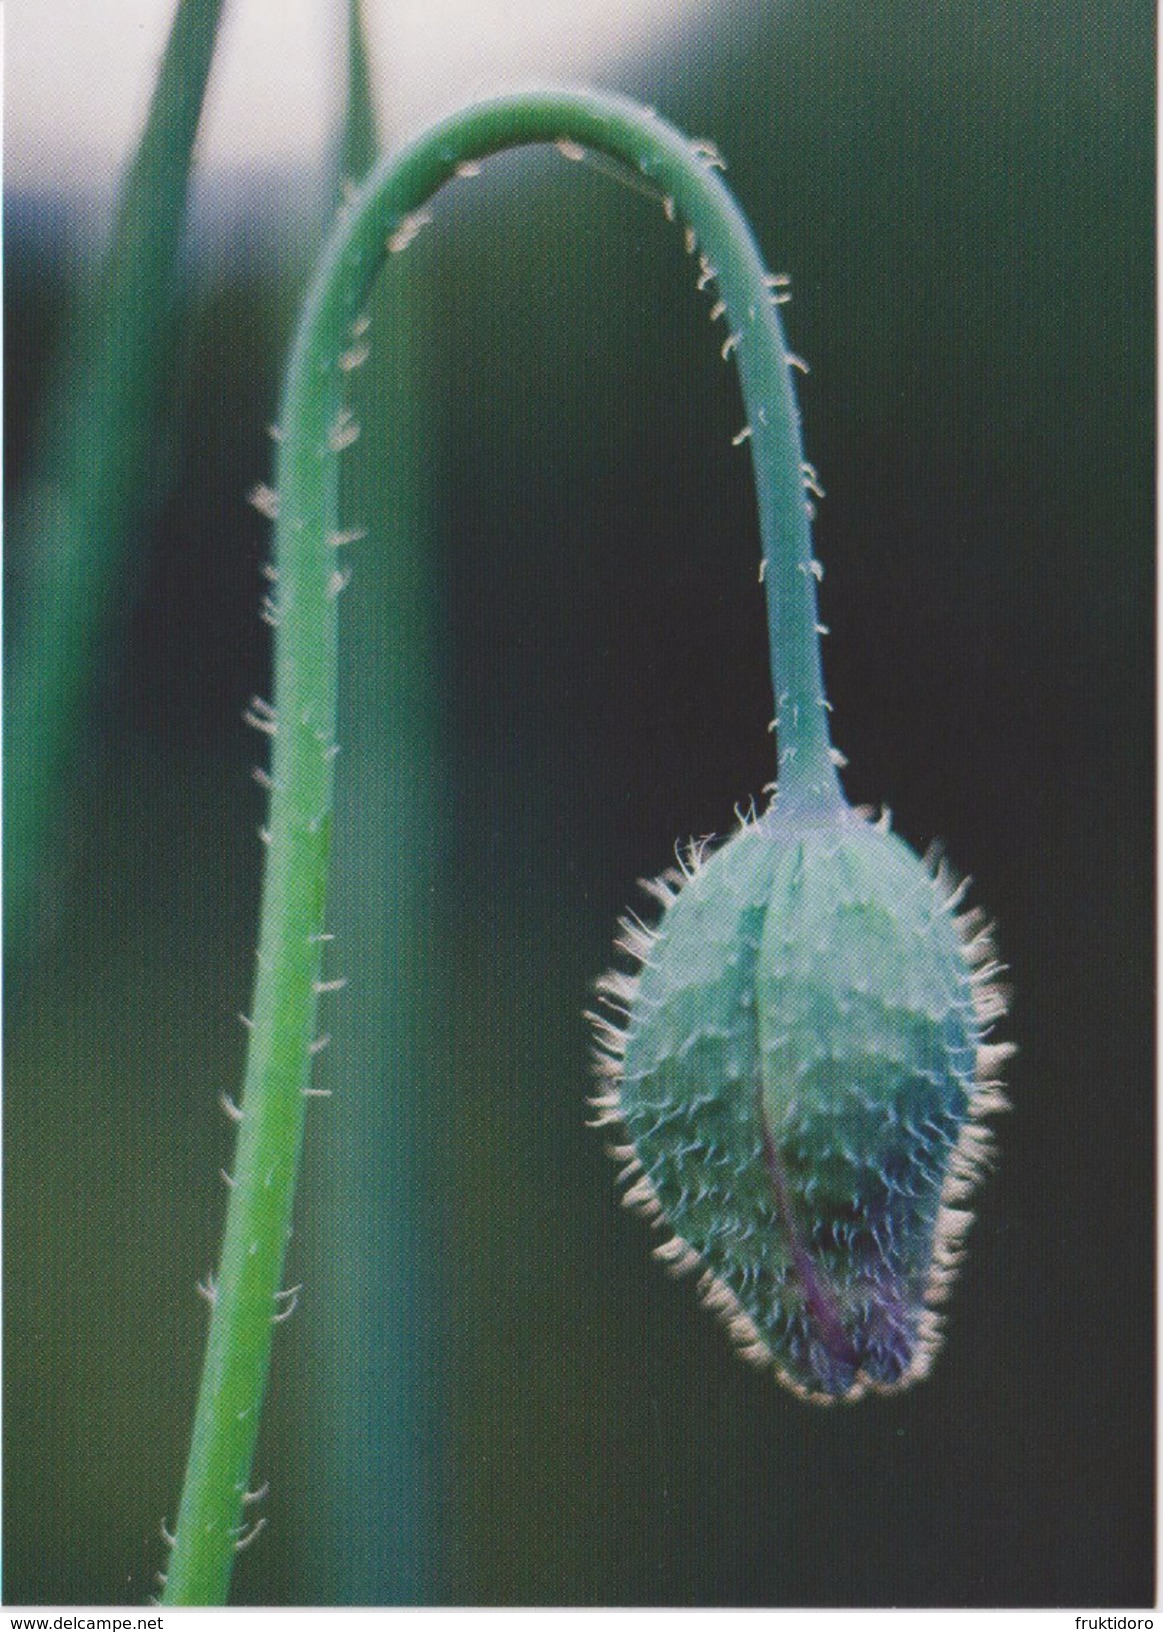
592, 806, 1011, 1402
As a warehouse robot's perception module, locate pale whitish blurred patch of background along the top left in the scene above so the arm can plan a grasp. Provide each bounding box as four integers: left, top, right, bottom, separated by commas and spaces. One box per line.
3, 0, 716, 188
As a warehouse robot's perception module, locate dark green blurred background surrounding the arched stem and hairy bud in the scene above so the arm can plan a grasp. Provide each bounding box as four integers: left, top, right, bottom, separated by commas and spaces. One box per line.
3, 0, 1155, 1608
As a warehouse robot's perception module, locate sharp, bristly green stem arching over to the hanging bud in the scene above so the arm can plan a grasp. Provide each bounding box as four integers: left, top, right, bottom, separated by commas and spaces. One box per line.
163, 91, 842, 1604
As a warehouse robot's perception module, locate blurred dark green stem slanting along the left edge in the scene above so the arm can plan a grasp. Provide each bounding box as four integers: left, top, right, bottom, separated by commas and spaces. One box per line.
3, 0, 222, 969
